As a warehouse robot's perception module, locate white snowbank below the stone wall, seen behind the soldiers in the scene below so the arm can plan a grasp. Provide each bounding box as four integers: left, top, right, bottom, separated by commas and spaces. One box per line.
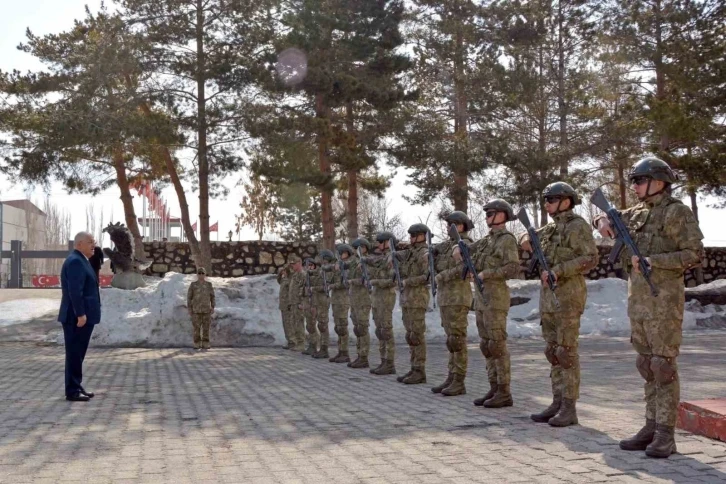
75, 273, 726, 347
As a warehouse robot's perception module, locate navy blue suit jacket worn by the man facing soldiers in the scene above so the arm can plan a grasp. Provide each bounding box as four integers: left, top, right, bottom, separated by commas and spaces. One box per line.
58, 250, 101, 326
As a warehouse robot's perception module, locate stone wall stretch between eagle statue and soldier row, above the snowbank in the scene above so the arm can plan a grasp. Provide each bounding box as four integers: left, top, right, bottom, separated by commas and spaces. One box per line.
144, 241, 317, 277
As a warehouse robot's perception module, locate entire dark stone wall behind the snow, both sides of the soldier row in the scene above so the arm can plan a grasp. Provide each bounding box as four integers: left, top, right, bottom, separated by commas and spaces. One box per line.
144, 241, 726, 287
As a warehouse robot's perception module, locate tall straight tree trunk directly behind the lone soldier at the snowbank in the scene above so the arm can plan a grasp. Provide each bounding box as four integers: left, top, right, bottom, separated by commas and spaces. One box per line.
195, 0, 213, 276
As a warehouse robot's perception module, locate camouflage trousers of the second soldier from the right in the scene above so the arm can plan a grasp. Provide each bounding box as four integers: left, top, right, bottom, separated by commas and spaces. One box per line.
542, 313, 580, 400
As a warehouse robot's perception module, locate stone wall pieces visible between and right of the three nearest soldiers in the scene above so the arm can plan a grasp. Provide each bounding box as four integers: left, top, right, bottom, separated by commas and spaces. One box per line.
520, 244, 726, 287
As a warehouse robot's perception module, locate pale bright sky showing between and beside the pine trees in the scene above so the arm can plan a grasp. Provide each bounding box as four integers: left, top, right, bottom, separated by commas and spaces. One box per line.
0, 0, 726, 246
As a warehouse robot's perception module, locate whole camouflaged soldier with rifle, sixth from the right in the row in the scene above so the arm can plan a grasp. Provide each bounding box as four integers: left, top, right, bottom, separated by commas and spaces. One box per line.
366, 232, 396, 375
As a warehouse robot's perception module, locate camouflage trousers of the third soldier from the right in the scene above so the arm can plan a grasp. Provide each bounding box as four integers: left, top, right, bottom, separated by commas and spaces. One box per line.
476, 309, 511, 385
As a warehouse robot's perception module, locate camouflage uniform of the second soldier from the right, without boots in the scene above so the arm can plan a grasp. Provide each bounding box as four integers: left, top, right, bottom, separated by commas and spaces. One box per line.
532, 210, 598, 422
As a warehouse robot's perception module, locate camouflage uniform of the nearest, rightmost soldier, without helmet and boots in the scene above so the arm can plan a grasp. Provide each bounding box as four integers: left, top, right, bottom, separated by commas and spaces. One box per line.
600, 193, 703, 427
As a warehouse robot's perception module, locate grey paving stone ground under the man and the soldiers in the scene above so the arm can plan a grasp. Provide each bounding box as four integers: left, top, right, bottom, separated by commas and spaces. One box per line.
0, 332, 726, 484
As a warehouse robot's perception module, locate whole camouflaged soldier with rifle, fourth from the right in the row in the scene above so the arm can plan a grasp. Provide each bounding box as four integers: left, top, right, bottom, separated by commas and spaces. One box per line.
431, 210, 474, 396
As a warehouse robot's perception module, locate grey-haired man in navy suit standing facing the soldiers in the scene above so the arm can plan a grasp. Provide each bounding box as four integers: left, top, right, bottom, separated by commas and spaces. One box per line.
58, 232, 101, 402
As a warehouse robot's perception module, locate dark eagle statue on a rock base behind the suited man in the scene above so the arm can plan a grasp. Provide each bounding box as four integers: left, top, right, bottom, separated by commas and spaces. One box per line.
103, 222, 150, 289
